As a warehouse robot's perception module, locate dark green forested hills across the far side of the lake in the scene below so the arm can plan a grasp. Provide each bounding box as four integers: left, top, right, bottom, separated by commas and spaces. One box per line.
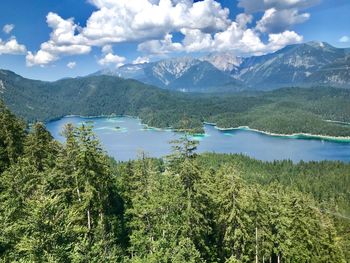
0, 71, 350, 136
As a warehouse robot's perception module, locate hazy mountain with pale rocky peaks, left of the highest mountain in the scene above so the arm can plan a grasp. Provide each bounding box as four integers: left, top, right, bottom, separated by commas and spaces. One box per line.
93, 57, 244, 92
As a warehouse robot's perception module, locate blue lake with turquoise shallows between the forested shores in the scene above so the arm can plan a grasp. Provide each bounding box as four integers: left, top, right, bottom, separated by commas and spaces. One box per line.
47, 117, 350, 162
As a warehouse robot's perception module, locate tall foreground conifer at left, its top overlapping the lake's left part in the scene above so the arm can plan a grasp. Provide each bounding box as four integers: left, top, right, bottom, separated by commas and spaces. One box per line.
61, 125, 123, 262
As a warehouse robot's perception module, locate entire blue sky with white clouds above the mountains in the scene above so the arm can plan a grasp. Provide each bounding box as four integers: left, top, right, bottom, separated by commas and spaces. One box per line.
0, 0, 350, 81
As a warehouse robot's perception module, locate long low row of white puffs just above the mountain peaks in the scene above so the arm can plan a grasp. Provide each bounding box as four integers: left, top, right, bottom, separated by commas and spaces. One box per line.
143, 22, 303, 55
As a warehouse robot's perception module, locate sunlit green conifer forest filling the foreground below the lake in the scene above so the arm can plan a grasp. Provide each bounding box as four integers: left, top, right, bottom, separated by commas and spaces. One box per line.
0, 103, 350, 263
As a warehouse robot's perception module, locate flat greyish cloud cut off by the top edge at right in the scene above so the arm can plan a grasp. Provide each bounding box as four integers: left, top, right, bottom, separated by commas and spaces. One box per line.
238, 0, 321, 13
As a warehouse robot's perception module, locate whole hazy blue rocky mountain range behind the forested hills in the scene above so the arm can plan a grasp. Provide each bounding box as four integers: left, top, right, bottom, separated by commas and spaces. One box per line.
93, 41, 350, 92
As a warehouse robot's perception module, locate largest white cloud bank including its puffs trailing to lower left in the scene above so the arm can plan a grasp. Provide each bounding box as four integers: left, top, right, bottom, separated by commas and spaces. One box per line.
27, 0, 230, 65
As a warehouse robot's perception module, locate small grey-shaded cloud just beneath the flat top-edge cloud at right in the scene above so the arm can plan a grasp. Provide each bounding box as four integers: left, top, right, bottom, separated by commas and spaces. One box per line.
256, 8, 310, 33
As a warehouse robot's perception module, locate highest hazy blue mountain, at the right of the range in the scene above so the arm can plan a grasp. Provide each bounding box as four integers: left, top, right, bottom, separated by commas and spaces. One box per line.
236, 42, 346, 89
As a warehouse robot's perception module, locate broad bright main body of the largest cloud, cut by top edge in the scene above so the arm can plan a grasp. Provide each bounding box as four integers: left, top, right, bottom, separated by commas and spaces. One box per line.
82, 0, 230, 45
